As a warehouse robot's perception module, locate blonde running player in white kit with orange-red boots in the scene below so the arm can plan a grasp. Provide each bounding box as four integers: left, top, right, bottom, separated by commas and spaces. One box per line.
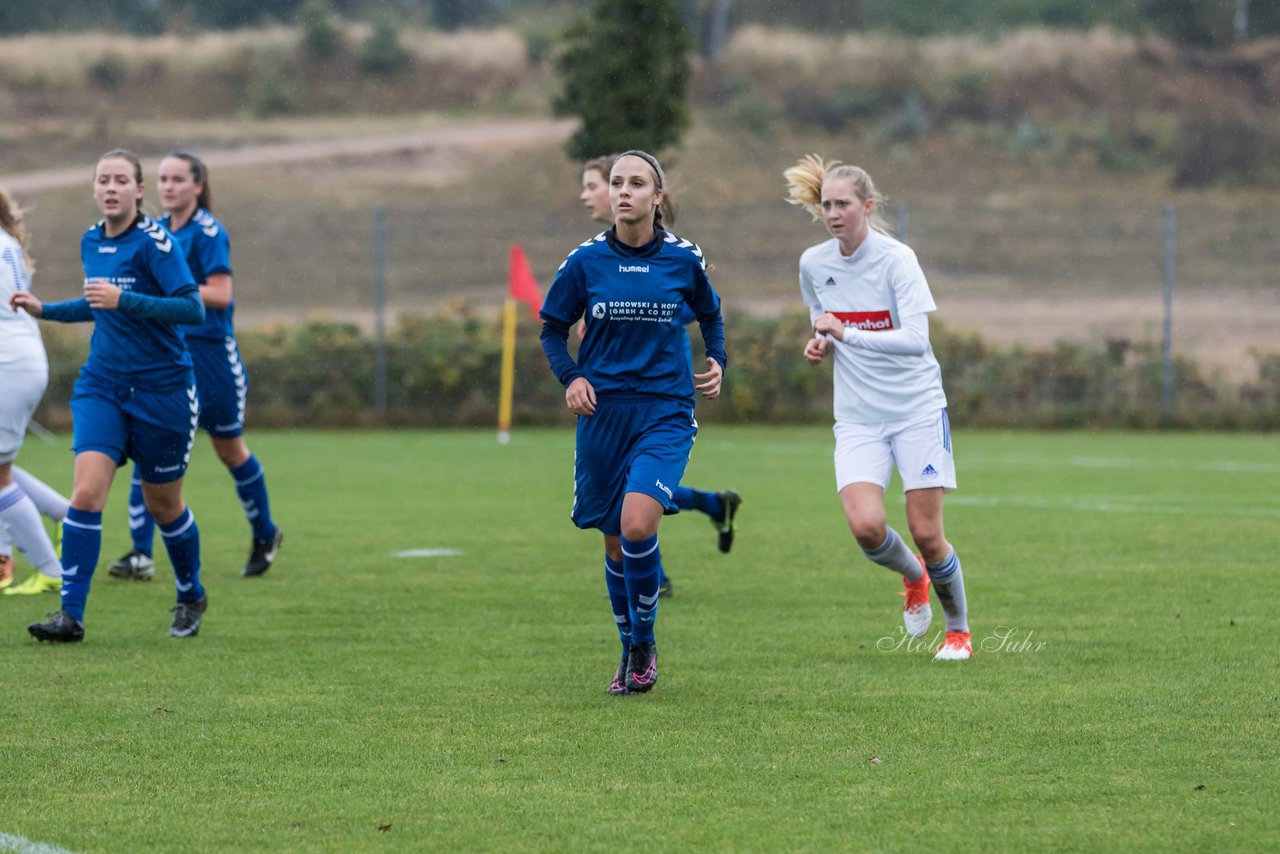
785, 155, 973, 661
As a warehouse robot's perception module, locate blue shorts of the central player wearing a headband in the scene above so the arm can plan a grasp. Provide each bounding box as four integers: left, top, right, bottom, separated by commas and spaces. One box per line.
572, 396, 698, 536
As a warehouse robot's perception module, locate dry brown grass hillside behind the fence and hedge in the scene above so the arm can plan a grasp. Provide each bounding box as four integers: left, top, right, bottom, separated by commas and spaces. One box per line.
0, 25, 1280, 376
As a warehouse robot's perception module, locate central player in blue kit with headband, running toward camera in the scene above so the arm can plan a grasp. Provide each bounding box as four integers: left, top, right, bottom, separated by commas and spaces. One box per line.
541, 151, 727, 694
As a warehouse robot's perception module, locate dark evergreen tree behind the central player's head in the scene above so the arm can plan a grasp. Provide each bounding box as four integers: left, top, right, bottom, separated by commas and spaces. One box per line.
553, 0, 692, 160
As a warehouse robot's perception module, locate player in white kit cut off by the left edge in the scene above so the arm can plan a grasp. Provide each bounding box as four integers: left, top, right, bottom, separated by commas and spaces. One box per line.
0, 191, 68, 594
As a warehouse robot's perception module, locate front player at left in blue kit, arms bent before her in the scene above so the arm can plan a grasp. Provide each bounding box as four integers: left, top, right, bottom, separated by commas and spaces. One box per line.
9, 149, 209, 643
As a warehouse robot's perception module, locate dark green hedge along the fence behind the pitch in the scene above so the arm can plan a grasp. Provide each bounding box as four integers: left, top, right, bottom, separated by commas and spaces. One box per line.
37, 307, 1280, 429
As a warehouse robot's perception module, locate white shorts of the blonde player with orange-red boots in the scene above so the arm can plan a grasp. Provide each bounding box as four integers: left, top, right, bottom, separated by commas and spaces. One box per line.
833, 408, 956, 492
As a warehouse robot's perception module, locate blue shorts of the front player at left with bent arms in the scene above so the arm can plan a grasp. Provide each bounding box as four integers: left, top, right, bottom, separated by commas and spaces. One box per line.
72, 375, 200, 484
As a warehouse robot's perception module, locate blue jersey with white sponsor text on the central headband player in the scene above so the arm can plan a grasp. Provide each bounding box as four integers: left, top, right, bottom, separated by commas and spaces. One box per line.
541, 229, 726, 398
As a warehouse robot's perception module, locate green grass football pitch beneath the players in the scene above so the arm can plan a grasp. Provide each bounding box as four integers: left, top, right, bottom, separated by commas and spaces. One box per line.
0, 425, 1280, 851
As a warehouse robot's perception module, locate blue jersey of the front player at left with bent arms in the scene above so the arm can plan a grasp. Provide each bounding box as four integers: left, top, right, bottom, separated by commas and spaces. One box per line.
81, 216, 196, 389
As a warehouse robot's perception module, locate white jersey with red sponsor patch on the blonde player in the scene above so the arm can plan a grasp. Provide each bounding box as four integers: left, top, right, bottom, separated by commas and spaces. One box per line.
800, 229, 947, 424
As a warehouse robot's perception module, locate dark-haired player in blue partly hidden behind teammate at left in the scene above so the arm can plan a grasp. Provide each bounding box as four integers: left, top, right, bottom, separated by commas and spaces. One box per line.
108, 151, 284, 581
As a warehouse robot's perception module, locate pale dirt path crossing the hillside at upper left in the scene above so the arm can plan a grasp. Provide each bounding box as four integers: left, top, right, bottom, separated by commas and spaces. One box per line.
0, 120, 573, 193
